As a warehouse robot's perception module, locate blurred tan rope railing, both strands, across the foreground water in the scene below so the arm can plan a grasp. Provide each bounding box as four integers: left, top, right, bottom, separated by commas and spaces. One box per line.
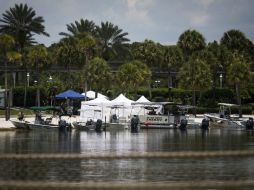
0, 150, 254, 190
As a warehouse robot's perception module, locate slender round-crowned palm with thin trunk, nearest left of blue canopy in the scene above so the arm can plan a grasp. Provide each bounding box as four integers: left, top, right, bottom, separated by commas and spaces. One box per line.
27, 45, 48, 106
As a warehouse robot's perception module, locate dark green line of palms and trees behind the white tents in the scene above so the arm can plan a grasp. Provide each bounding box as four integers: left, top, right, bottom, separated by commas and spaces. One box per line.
0, 4, 254, 113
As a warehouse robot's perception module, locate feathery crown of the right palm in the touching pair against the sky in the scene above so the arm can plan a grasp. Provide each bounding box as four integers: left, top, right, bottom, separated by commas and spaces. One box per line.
96, 22, 130, 60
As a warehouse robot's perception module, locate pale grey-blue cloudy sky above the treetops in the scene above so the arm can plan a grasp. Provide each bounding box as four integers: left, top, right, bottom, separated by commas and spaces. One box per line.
0, 0, 254, 46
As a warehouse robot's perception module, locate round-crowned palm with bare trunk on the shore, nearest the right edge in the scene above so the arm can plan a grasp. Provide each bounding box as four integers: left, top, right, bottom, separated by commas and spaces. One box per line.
228, 54, 250, 117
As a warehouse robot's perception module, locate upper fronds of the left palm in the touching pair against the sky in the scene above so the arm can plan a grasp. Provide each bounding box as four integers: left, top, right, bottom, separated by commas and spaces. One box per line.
59, 19, 96, 37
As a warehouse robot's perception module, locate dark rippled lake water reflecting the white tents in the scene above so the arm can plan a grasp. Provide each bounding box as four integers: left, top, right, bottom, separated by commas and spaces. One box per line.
0, 129, 254, 185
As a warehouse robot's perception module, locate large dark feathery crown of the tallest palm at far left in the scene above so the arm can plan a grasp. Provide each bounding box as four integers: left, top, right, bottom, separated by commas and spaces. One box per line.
0, 3, 49, 50
